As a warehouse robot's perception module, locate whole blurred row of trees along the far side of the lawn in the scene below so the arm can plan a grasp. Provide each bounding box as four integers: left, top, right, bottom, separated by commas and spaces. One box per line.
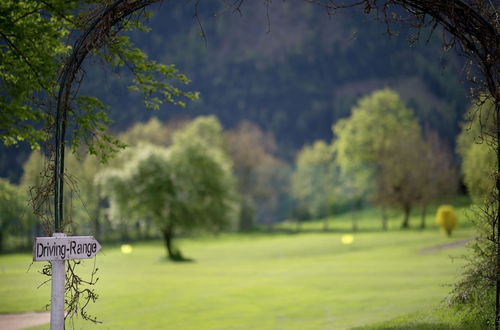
6, 89, 464, 250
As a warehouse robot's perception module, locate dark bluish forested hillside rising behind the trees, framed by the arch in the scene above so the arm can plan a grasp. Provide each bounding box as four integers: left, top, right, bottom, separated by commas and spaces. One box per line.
0, 0, 468, 181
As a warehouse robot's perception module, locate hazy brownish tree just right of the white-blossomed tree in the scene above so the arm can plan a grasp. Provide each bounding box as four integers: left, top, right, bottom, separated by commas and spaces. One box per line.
225, 121, 289, 230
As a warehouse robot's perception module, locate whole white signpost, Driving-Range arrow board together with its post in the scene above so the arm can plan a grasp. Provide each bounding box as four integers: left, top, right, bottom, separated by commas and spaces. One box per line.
33, 233, 101, 330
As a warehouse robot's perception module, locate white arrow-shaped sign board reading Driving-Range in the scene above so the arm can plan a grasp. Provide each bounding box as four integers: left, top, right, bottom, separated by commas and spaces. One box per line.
33, 235, 101, 261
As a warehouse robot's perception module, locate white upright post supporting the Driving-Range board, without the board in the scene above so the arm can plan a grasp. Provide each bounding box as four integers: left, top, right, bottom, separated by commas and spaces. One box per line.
50, 233, 66, 330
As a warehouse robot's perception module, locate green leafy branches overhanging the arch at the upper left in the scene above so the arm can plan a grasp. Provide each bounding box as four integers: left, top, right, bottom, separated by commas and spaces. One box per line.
0, 0, 198, 179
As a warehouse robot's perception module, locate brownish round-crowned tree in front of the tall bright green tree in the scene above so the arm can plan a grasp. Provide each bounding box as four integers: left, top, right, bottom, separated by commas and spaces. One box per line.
376, 121, 457, 229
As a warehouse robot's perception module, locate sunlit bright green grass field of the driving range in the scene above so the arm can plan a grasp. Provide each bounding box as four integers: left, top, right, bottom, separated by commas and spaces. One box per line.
0, 205, 473, 329
